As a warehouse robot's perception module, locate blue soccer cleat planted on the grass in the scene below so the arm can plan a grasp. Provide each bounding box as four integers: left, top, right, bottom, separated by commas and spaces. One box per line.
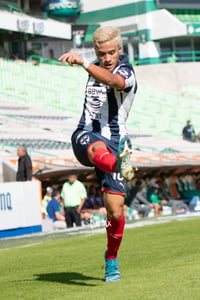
105, 253, 120, 282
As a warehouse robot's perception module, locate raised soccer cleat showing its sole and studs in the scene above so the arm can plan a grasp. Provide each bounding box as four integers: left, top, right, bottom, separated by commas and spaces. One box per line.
117, 136, 135, 181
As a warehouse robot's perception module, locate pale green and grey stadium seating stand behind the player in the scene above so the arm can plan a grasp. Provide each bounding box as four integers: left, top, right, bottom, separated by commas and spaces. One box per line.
0, 60, 200, 182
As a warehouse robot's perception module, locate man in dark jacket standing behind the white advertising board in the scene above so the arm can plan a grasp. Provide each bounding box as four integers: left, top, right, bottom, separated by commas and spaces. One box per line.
16, 146, 32, 181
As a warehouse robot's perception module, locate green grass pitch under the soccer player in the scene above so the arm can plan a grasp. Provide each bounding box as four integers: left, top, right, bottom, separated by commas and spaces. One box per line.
0, 218, 200, 300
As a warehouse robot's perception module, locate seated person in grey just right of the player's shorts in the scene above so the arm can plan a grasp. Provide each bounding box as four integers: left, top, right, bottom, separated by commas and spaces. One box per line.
130, 180, 154, 218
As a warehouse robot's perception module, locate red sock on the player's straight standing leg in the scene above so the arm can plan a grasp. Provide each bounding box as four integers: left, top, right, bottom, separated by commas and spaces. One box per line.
106, 215, 125, 259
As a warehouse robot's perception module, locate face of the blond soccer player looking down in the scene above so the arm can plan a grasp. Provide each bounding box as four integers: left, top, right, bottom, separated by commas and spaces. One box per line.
95, 41, 121, 72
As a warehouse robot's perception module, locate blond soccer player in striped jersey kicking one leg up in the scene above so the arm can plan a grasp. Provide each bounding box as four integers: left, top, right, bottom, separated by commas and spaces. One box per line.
59, 27, 137, 281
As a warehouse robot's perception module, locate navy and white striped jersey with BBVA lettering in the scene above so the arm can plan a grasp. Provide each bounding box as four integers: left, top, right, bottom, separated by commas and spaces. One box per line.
78, 55, 137, 142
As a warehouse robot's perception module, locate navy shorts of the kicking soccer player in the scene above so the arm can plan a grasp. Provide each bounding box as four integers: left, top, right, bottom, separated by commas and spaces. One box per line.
71, 130, 126, 195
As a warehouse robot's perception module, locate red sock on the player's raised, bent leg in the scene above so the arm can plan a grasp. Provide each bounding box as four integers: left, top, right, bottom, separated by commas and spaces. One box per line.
92, 148, 117, 173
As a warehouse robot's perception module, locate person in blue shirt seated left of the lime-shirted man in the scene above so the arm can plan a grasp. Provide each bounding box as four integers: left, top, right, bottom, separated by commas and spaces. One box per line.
47, 190, 66, 229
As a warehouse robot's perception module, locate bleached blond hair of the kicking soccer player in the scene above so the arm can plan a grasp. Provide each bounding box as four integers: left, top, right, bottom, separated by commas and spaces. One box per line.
93, 26, 121, 48
